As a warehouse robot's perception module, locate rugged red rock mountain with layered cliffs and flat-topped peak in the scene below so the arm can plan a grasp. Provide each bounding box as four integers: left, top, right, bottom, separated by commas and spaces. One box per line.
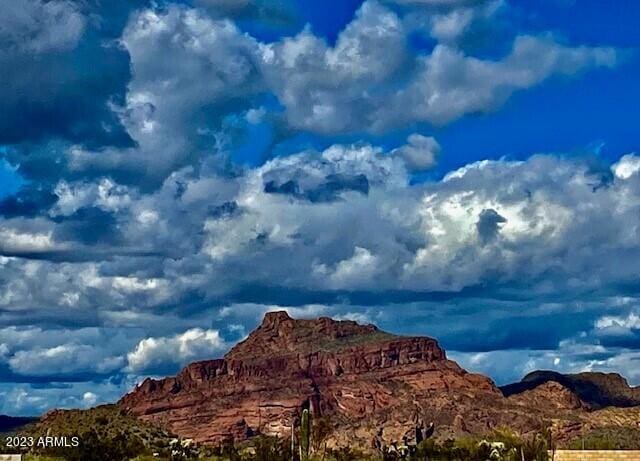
119, 312, 503, 443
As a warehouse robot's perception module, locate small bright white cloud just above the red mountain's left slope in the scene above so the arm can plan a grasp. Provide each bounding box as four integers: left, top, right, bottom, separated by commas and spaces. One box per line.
127, 328, 228, 372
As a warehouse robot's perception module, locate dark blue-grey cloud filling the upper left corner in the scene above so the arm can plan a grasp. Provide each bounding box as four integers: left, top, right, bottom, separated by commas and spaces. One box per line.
0, 0, 143, 147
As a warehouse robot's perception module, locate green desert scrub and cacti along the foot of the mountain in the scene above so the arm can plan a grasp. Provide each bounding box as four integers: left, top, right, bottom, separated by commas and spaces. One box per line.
8, 405, 640, 461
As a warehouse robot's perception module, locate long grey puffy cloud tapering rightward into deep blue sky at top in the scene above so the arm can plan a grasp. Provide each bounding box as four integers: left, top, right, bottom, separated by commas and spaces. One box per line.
262, 1, 616, 133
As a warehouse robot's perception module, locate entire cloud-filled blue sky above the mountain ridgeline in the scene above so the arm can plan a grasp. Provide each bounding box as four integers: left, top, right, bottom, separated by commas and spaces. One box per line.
0, 0, 640, 415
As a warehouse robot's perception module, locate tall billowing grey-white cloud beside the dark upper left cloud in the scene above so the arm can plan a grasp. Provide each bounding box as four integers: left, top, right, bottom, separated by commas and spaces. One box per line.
69, 6, 262, 185
